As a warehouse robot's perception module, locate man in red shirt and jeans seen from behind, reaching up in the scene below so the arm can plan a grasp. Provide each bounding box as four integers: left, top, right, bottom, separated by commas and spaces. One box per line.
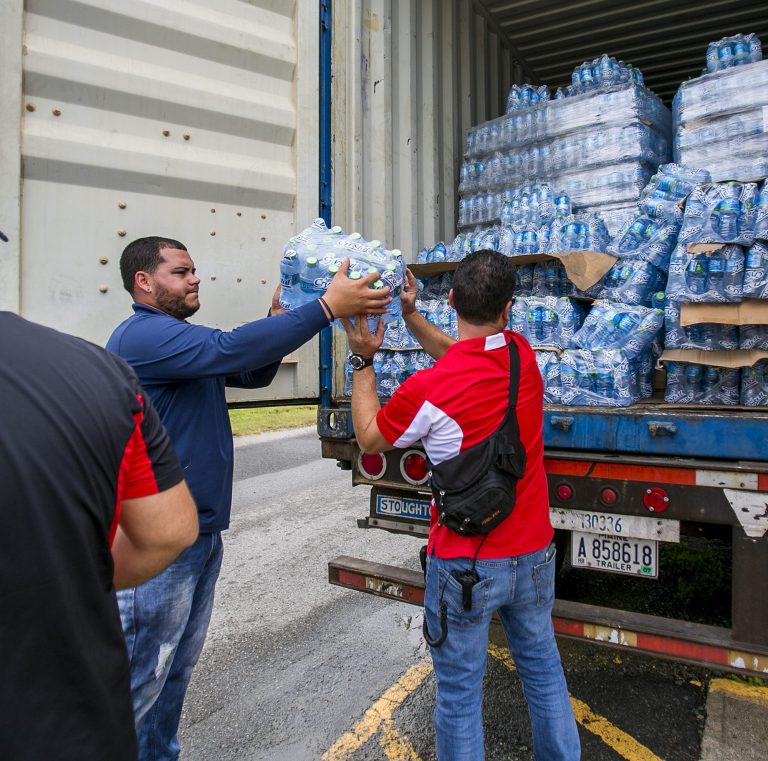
345, 251, 580, 761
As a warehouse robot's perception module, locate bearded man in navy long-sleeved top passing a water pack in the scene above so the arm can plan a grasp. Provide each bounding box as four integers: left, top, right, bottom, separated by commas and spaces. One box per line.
107, 237, 391, 761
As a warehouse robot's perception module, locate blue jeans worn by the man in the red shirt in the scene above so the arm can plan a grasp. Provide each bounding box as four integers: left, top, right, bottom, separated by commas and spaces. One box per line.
424, 548, 580, 761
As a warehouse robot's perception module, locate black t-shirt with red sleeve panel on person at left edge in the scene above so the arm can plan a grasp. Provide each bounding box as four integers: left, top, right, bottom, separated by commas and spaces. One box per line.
0, 312, 182, 761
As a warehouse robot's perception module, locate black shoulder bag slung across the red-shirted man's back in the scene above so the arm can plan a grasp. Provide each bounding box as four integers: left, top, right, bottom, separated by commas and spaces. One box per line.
430, 340, 525, 536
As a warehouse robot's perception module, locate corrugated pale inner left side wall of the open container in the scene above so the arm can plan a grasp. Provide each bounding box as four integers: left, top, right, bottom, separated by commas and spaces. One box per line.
332, 0, 524, 392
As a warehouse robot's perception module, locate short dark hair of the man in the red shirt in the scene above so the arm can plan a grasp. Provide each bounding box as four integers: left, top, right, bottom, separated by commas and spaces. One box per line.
453, 249, 515, 325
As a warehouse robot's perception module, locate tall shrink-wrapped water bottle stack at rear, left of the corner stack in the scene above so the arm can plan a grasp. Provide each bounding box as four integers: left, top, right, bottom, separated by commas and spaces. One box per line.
459, 56, 672, 218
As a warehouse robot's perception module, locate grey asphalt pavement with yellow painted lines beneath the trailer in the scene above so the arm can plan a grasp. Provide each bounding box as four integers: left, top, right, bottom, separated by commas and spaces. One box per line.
180, 429, 768, 761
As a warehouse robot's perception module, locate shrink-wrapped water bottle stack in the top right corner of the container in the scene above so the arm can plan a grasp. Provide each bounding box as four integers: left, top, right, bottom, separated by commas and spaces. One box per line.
672, 35, 768, 181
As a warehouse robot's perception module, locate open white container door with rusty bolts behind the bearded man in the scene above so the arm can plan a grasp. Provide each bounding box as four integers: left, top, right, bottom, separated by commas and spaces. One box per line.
0, 0, 319, 399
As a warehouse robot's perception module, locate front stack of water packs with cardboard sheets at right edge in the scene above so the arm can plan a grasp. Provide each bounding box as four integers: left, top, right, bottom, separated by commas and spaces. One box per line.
664, 181, 768, 406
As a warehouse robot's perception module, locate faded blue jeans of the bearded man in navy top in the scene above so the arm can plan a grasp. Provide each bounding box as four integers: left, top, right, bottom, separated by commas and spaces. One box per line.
117, 532, 223, 761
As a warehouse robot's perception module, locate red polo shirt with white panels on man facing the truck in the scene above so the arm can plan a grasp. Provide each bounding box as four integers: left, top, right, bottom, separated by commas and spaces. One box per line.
376, 330, 553, 558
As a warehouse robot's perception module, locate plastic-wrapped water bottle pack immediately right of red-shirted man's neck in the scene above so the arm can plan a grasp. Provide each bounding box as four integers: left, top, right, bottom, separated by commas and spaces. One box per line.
509, 296, 584, 349
